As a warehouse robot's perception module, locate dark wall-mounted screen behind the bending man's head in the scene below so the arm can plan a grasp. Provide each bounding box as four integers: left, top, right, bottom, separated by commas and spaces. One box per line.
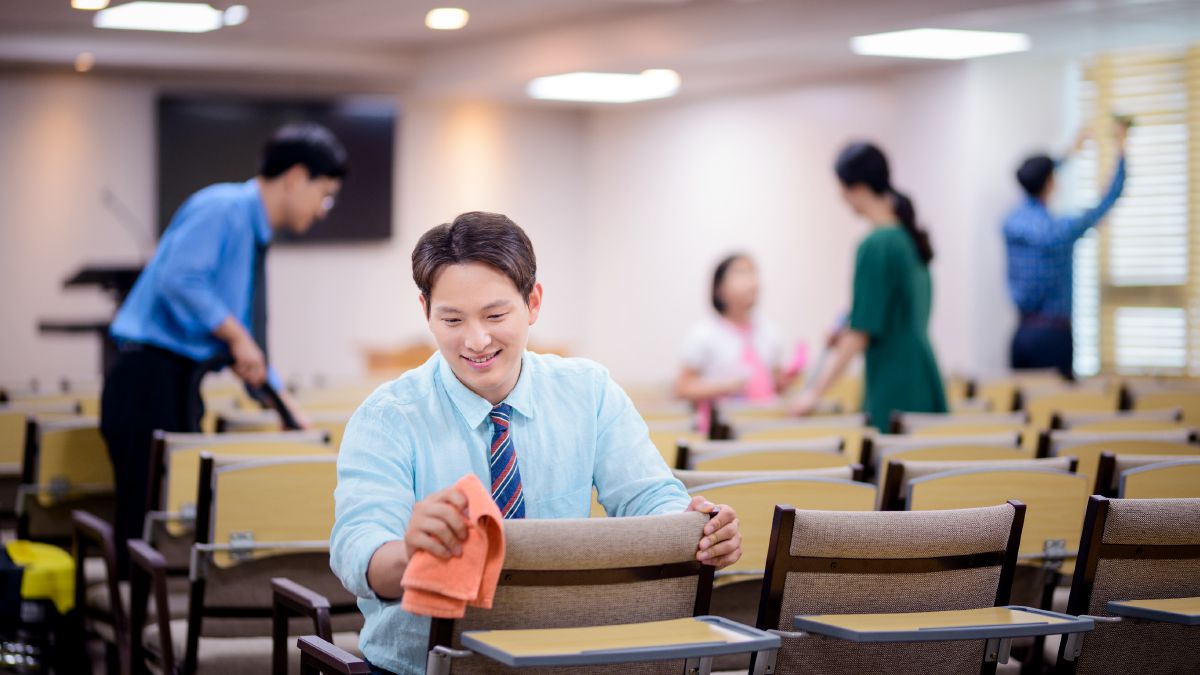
158, 96, 396, 244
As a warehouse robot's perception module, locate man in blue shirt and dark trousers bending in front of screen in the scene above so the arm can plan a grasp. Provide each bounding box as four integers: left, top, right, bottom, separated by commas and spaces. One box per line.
101, 124, 346, 574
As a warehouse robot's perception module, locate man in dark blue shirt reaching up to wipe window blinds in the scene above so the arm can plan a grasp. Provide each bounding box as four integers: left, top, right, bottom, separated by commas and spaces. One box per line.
1004, 123, 1129, 377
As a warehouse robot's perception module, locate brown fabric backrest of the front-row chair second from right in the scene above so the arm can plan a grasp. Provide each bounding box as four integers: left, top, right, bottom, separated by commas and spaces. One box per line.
757, 502, 1025, 673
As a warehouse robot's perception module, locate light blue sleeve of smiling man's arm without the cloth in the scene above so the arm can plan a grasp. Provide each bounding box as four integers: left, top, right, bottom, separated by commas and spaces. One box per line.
593, 371, 690, 516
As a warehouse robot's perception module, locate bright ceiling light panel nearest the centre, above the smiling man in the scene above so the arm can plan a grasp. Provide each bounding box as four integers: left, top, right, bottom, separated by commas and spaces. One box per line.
526, 68, 679, 103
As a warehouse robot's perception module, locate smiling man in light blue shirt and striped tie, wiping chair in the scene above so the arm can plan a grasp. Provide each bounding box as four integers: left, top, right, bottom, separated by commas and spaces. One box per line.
330, 213, 742, 674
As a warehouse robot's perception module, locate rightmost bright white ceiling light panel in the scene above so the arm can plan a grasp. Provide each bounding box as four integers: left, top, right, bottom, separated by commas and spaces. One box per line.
850, 28, 1032, 60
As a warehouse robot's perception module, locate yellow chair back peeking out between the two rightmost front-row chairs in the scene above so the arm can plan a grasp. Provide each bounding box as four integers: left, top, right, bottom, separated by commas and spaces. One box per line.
907, 467, 1091, 573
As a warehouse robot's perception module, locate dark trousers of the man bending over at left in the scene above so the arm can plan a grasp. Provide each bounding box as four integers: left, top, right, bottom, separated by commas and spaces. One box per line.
100, 345, 204, 577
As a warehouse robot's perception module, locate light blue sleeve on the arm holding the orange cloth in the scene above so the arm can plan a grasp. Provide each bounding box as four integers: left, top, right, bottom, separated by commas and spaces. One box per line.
330, 393, 414, 599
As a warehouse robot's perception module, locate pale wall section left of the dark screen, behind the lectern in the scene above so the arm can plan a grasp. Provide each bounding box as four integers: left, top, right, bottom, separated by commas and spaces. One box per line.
0, 76, 155, 381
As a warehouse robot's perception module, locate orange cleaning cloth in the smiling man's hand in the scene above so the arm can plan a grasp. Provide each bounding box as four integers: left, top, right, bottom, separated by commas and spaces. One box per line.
400, 473, 504, 619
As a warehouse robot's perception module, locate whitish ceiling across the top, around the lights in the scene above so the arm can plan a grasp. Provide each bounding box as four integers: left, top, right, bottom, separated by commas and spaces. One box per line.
0, 0, 1200, 100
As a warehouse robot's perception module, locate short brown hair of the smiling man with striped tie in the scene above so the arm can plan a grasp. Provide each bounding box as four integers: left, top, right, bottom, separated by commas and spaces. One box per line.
413, 211, 538, 315
